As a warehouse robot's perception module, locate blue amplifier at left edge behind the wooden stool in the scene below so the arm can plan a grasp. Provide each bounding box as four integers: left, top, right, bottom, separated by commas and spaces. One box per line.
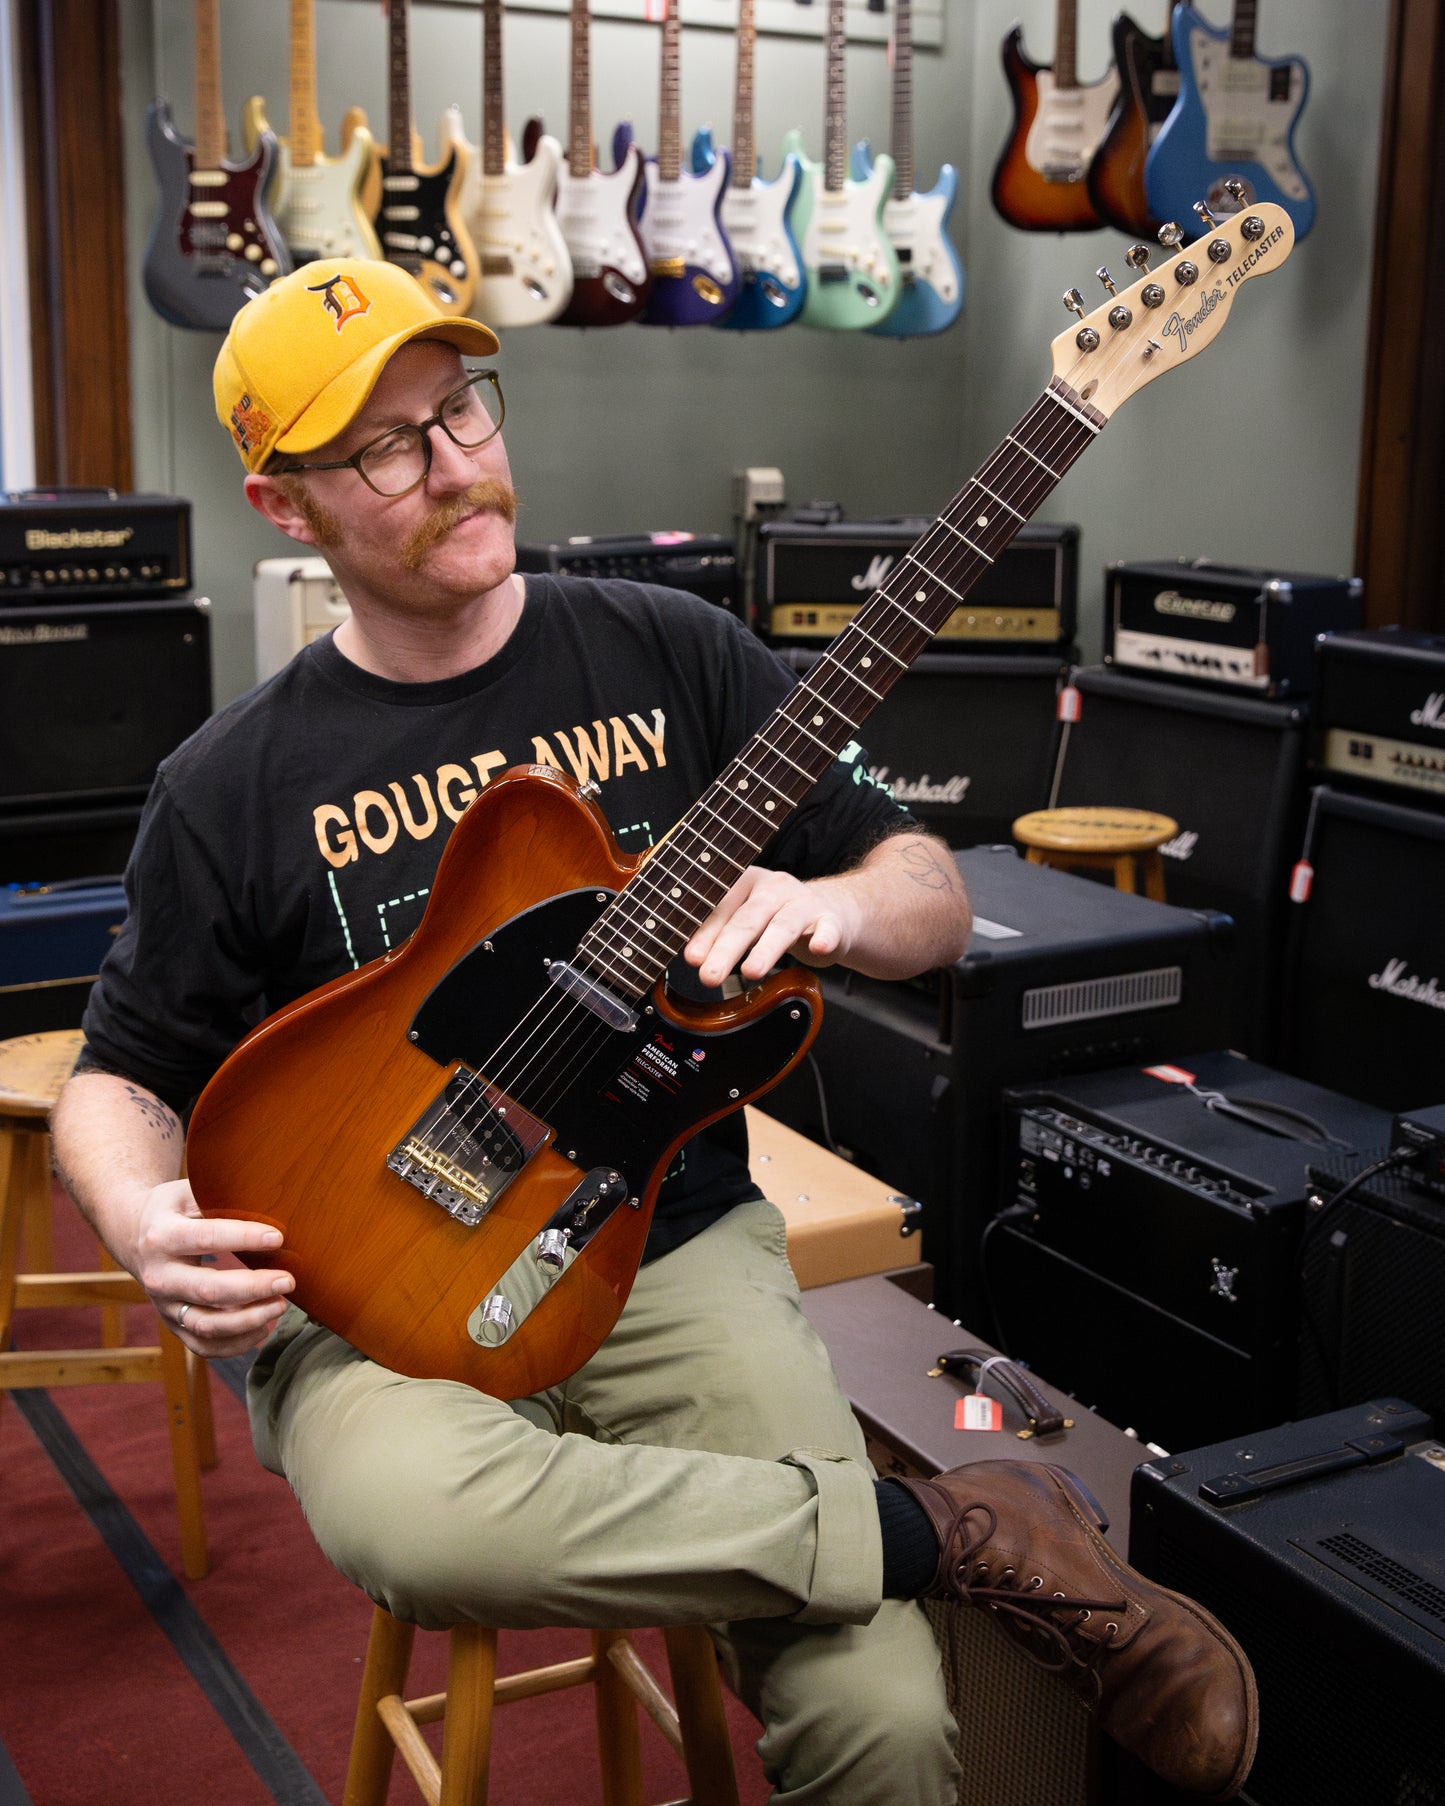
0, 880, 125, 1037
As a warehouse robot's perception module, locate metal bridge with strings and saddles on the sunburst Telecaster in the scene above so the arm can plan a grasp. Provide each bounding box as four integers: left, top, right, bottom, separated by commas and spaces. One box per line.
387, 1067, 551, 1228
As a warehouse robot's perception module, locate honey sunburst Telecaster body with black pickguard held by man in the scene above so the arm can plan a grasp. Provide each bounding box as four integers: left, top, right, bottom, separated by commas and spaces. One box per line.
188, 766, 818, 1398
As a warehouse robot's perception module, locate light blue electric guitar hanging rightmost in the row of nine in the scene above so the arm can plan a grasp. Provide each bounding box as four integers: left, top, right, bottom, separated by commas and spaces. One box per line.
853, 0, 963, 338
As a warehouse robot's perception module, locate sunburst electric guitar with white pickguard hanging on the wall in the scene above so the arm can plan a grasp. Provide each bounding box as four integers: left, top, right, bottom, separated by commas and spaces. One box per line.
992, 0, 1118, 231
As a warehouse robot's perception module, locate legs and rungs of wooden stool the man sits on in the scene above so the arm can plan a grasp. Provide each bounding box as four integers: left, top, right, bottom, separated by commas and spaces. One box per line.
341, 1606, 737, 1806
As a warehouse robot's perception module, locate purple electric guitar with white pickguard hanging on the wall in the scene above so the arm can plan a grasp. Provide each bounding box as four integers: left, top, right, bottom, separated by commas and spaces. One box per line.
639, 0, 742, 327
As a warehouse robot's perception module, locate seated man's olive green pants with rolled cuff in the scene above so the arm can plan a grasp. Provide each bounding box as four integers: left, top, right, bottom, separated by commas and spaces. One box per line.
251, 1203, 957, 1806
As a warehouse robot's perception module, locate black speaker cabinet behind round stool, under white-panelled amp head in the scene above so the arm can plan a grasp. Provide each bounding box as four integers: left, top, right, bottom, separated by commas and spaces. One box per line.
1051, 666, 1307, 1054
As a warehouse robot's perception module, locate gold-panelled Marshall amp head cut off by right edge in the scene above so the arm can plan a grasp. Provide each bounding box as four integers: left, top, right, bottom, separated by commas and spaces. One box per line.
1313, 627, 1445, 807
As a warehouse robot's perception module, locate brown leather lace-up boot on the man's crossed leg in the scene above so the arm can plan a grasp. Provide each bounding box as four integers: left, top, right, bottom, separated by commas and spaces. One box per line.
892, 1461, 1259, 1801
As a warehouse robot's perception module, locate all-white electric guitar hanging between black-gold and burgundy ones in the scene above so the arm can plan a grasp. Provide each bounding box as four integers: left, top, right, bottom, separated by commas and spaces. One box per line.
441, 0, 573, 327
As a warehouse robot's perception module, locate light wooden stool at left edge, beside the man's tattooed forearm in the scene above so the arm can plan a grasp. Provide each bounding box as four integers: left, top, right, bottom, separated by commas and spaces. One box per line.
0, 1029, 215, 1580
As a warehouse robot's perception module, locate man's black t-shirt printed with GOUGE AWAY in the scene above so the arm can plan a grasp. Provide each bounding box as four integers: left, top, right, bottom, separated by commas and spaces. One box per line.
83, 576, 916, 1255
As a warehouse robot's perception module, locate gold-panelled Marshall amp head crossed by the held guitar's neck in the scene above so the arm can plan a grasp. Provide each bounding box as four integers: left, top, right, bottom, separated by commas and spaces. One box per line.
757, 517, 1078, 652
